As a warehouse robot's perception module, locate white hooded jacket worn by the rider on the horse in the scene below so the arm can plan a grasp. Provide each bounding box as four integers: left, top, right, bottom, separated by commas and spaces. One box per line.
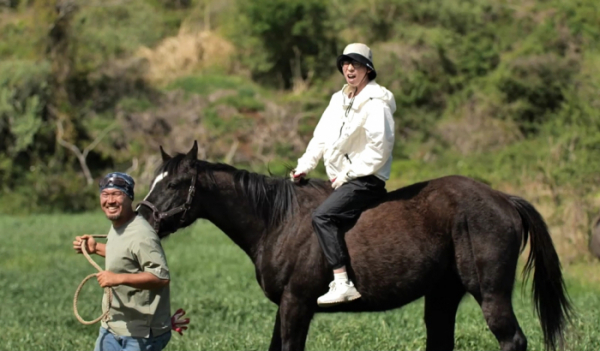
296, 81, 396, 181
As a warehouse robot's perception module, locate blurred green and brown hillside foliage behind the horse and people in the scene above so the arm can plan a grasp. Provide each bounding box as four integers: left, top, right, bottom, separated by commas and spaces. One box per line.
0, 0, 600, 262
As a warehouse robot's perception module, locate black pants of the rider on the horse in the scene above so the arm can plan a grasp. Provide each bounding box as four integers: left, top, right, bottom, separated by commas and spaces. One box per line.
312, 175, 386, 269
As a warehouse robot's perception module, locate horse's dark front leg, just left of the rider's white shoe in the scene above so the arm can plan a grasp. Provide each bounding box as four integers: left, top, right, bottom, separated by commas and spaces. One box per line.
280, 293, 316, 351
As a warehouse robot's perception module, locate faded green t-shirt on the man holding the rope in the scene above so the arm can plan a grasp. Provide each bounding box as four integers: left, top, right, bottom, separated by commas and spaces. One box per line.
102, 215, 171, 338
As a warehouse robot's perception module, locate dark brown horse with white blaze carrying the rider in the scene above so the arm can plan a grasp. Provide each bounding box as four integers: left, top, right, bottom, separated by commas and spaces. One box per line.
139, 143, 571, 350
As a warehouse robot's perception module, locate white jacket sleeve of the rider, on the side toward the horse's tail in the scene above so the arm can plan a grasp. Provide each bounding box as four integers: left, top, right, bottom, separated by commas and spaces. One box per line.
348, 100, 394, 178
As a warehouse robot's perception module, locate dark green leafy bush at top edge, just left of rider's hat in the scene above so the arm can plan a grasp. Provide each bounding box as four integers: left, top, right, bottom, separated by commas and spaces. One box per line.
225, 0, 338, 89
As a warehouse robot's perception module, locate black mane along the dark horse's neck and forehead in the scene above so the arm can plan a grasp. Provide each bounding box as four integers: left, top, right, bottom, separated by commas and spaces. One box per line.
156, 154, 328, 228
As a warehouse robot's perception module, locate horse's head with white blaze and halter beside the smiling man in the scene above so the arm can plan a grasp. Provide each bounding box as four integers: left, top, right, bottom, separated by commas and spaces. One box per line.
138, 141, 199, 238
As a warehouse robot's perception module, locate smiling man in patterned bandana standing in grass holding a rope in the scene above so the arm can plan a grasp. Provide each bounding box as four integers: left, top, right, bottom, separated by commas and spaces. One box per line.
73, 172, 171, 351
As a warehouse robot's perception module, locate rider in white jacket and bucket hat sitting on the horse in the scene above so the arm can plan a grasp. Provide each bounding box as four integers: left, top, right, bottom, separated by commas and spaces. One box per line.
291, 43, 396, 306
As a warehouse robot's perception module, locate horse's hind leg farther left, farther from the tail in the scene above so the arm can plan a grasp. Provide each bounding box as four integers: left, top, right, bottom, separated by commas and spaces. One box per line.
425, 278, 465, 351
